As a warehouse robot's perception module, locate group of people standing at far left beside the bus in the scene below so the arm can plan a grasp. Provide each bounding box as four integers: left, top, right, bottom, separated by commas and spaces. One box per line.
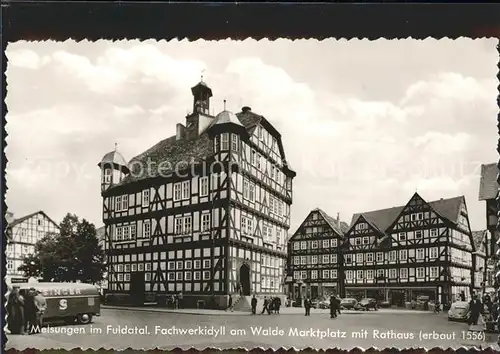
6, 286, 47, 334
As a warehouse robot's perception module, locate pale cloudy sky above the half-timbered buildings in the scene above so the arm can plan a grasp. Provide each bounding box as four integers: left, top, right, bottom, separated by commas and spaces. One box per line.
6, 38, 498, 233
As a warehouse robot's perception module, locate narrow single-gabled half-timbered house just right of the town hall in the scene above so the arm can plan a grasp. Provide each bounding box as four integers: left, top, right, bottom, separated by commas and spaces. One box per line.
288, 208, 348, 299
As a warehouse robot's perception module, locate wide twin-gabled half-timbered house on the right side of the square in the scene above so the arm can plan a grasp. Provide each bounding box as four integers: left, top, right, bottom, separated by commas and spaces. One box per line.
343, 193, 474, 306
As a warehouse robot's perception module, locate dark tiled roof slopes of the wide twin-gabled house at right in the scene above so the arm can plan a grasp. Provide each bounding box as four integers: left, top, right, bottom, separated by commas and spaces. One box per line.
351, 196, 464, 233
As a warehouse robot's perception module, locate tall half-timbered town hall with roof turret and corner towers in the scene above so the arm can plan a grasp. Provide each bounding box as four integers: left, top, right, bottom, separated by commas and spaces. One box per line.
99, 81, 295, 307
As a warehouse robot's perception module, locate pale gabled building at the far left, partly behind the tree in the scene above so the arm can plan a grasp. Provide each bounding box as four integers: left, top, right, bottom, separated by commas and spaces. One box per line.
5, 211, 59, 283
